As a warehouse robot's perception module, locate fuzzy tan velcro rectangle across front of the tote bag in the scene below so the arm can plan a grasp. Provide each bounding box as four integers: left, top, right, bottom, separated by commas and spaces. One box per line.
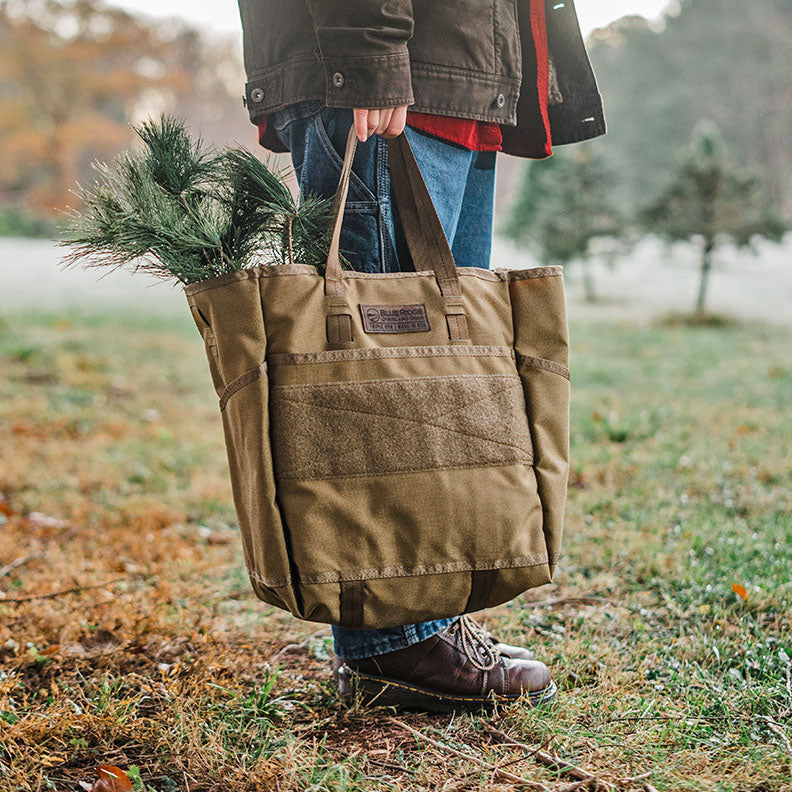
270, 374, 533, 480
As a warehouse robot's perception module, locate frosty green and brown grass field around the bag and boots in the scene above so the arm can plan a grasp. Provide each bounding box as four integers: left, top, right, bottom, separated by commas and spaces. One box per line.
0, 311, 792, 792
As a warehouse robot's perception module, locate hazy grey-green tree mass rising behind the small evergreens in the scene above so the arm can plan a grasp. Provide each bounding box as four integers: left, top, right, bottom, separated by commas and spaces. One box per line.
589, 0, 792, 218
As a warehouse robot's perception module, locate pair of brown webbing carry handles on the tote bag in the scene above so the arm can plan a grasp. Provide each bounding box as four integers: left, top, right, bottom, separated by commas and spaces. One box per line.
325, 126, 468, 341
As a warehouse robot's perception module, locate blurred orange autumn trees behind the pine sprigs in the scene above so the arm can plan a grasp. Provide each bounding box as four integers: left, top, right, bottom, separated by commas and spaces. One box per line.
0, 0, 250, 230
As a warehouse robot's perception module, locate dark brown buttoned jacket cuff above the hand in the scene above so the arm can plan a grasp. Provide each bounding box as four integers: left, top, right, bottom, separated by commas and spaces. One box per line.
322, 48, 415, 109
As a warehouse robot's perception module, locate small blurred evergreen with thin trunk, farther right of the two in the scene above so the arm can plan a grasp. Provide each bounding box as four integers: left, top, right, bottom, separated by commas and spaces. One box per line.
639, 122, 787, 316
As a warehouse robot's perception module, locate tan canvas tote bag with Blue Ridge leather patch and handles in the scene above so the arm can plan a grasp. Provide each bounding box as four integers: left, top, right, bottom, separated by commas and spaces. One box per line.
185, 130, 569, 628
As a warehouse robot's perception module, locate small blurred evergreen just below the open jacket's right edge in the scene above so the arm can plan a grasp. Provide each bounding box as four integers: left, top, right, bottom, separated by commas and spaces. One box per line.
504, 145, 624, 302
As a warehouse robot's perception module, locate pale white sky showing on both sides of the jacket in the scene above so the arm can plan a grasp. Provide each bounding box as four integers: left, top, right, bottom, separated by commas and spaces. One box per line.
111, 0, 668, 39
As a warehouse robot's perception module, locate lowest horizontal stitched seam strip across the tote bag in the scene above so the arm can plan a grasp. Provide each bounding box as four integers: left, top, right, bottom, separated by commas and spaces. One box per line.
248, 553, 558, 588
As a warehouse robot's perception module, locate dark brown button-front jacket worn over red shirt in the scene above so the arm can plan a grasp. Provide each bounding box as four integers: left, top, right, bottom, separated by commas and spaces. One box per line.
239, 0, 605, 157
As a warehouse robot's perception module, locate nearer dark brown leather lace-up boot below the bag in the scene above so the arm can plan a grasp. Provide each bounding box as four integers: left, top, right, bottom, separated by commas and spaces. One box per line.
333, 615, 556, 712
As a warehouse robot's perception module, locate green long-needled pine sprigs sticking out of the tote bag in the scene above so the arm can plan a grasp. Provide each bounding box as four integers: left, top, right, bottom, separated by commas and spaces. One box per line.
62, 116, 331, 284
